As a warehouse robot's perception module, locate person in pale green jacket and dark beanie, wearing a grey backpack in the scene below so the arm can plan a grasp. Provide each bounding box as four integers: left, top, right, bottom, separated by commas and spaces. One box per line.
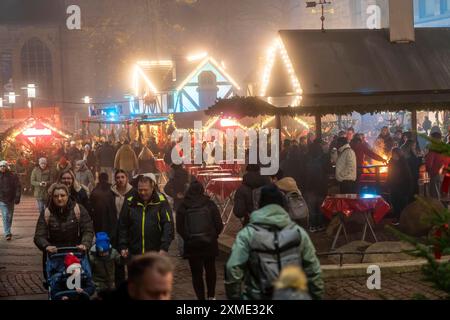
225, 185, 324, 300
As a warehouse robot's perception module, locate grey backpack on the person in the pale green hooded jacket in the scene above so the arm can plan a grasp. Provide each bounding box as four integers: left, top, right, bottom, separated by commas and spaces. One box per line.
249, 223, 302, 299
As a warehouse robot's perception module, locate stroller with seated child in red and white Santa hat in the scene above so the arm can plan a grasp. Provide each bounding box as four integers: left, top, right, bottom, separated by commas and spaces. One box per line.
46, 248, 95, 300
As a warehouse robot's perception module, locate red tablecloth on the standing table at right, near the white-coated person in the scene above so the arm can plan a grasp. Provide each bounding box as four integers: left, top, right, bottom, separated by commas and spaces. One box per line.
322, 195, 391, 223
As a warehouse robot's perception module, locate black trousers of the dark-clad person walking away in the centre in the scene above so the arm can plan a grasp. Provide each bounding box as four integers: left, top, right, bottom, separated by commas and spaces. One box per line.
189, 257, 217, 300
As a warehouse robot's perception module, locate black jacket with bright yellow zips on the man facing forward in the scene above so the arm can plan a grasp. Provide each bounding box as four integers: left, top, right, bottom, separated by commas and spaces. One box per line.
119, 191, 175, 255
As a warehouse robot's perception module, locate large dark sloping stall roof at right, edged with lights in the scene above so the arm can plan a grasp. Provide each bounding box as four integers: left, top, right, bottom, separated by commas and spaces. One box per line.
266, 28, 450, 115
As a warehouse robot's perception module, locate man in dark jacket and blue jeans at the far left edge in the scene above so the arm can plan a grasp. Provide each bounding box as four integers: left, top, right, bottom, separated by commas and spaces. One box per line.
0, 161, 21, 241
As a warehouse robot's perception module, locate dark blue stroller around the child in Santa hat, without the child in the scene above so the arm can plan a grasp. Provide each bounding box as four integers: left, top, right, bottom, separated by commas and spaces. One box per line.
45, 247, 95, 300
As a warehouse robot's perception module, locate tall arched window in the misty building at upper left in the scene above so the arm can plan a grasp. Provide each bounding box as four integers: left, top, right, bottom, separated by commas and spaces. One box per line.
21, 38, 53, 99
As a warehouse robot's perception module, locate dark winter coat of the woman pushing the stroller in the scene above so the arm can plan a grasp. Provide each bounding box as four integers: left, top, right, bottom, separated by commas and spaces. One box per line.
34, 199, 94, 251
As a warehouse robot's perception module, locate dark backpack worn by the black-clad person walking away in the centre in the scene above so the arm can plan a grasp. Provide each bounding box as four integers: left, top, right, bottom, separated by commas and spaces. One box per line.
185, 205, 217, 248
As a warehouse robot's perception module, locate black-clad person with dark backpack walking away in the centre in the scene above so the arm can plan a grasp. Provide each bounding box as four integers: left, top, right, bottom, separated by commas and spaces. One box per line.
176, 181, 223, 300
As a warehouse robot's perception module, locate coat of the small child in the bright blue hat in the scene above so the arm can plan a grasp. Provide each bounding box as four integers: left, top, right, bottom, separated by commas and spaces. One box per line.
89, 245, 121, 291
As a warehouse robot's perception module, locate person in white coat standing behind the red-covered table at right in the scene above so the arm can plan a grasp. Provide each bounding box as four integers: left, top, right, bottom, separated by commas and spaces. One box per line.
336, 137, 357, 194
